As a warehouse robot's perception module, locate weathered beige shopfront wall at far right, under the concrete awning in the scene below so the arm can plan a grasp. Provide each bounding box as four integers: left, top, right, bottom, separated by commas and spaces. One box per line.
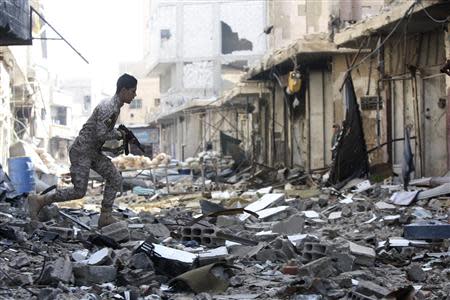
385, 30, 448, 176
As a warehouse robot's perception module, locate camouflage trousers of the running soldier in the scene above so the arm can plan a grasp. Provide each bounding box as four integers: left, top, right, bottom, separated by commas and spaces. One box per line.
52, 148, 122, 212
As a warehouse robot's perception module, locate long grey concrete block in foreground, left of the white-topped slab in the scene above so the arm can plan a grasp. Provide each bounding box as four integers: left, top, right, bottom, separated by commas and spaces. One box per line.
73, 264, 117, 285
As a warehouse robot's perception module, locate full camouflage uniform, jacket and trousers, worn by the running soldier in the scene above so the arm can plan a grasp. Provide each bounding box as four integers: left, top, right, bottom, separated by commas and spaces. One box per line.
52, 95, 123, 212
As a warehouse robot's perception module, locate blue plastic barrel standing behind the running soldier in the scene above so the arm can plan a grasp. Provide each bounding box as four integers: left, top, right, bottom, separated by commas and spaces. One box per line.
8, 156, 35, 194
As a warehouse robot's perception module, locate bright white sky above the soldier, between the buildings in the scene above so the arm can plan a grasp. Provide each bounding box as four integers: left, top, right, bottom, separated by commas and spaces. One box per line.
41, 0, 144, 93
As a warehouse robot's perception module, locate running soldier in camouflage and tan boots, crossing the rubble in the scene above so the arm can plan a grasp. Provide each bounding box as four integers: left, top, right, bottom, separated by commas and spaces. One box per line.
28, 74, 137, 228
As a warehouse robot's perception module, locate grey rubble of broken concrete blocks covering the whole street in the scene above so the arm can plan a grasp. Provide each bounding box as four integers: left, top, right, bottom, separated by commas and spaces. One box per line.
0, 165, 450, 299
